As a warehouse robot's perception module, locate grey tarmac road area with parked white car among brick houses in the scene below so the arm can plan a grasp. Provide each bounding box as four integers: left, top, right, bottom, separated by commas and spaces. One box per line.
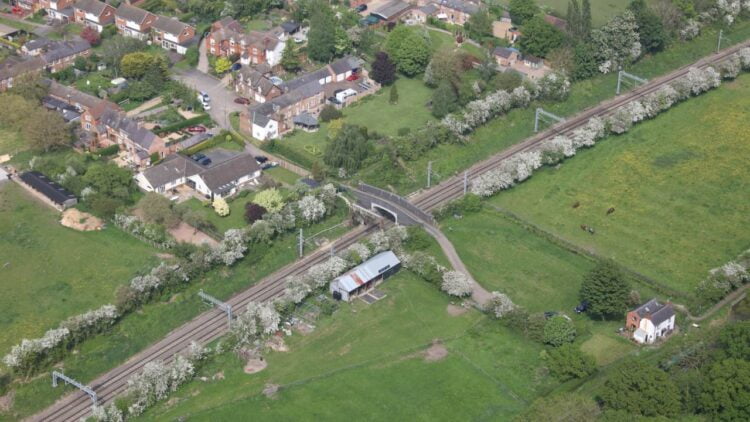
173, 69, 247, 130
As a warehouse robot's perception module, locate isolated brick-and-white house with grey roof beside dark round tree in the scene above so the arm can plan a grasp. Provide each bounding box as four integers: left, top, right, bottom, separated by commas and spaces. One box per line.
625, 299, 675, 344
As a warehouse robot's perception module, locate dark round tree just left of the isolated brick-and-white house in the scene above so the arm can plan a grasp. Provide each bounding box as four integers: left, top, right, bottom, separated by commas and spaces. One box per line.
580, 262, 630, 318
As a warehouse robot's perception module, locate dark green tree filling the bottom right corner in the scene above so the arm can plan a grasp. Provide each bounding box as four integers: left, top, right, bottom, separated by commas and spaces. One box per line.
699, 359, 750, 421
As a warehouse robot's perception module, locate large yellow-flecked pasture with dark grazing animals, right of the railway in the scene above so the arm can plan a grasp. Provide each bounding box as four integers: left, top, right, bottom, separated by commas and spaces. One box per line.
490, 75, 750, 292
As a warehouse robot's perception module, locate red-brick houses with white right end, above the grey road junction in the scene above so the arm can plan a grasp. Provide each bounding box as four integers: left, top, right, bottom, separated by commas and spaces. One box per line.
205, 17, 284, 66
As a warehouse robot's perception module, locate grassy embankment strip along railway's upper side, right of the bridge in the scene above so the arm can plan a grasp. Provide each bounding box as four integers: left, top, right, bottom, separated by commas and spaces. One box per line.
374, 21, 750, 193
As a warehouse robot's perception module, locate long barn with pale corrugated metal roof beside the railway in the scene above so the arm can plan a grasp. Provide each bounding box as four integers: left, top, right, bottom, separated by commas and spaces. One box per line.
329, 251, 401, 302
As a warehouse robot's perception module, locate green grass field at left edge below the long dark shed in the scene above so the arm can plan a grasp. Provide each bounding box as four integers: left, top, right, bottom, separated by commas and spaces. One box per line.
0, 183, 156, 355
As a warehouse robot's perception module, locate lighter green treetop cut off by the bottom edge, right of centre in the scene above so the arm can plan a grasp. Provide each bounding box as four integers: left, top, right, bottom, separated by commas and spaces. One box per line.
517, 393, 601, 422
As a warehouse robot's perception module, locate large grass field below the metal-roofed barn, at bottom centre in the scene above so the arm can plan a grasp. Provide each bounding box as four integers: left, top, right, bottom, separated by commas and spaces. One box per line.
140, 271, 550, 420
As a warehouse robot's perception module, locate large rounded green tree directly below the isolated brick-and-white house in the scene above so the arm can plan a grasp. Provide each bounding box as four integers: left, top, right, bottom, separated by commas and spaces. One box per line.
599, 359, 680, 417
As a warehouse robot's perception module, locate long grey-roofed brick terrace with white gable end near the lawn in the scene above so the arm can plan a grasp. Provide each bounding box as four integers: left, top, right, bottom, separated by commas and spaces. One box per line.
240, 56, 379, 140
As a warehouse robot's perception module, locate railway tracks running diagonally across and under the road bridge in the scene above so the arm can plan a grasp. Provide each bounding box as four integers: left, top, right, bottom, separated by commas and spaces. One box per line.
28, 42, 750, 421
